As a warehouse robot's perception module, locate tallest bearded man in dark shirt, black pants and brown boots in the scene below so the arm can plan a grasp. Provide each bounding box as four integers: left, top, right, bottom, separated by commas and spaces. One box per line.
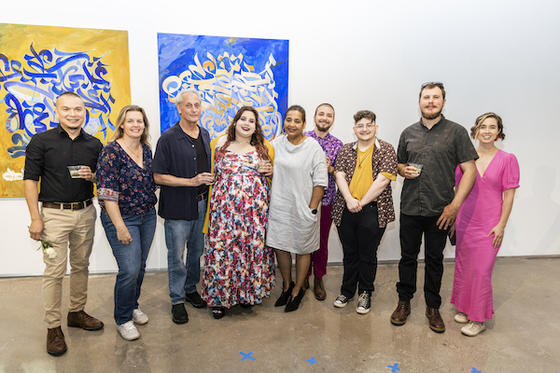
391, 82, 478, 333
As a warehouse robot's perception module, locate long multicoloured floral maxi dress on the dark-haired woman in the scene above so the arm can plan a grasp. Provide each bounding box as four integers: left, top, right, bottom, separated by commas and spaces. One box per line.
202, 151, 275, 308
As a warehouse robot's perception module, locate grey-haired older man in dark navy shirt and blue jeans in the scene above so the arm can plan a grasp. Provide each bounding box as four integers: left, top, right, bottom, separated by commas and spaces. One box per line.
152, 91, 213, 324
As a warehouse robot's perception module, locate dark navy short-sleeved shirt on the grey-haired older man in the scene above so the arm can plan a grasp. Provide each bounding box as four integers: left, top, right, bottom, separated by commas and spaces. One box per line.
152, 123, 210, 220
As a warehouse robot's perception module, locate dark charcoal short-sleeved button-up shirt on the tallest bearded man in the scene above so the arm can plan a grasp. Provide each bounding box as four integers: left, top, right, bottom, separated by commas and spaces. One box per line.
397, 116, 478, 216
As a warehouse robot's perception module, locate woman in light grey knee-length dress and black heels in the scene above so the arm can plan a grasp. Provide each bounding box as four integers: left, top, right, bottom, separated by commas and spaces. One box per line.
266, 105, 328, 312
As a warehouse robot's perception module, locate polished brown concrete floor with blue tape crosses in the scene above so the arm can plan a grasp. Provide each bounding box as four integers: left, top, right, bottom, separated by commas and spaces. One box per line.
0, 258, 560, 373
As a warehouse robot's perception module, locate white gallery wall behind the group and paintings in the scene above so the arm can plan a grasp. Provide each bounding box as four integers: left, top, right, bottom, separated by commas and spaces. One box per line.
0, 0, 560, 276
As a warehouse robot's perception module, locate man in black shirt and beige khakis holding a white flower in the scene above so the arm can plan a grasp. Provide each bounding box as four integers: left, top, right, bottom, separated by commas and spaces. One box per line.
23, 92, 103, 356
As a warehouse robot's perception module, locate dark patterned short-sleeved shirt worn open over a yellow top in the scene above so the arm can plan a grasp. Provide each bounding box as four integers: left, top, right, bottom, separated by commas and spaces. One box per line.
331, 139, 397, 228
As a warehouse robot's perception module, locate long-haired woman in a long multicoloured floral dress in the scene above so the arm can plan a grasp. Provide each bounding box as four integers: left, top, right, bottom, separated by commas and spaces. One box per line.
202, 106, 275, 319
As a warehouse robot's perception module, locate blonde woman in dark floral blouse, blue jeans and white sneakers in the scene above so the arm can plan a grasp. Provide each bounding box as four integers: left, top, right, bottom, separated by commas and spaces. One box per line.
97, 105, 157, 340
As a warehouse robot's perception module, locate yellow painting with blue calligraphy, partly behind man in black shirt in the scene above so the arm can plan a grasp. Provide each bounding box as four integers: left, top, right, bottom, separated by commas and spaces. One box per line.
0, 23, 130, 198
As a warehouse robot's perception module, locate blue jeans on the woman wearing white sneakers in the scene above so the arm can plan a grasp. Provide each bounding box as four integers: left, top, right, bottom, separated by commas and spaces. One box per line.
101, 209, 157, 325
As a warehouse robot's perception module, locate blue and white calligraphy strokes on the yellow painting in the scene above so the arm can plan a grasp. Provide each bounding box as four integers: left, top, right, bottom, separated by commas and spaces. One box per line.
0, 43, 115, 158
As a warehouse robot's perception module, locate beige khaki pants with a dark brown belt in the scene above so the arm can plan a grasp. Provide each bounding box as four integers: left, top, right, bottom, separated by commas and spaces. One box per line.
41, 205, 97, 328
